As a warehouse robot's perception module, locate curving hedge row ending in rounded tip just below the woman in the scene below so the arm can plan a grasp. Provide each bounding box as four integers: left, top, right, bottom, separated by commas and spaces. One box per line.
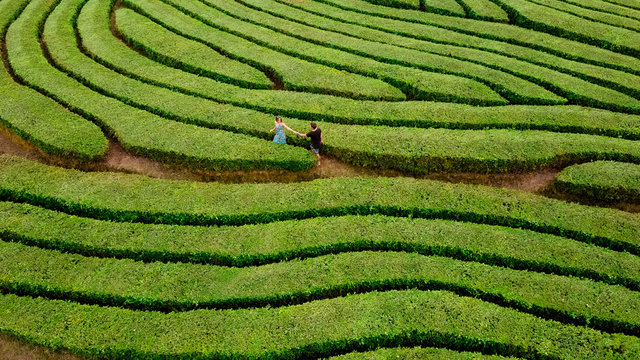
7, 2, 314, 170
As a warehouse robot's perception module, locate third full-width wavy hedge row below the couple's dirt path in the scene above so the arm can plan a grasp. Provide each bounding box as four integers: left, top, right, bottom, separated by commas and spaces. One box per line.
0, 242, 640, 335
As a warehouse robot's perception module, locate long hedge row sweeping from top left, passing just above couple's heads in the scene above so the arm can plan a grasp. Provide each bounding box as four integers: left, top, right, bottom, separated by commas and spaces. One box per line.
78, 0, 640, 141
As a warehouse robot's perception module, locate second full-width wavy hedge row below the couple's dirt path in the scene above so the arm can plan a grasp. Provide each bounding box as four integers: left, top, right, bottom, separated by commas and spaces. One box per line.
0, 202, 640, 290
